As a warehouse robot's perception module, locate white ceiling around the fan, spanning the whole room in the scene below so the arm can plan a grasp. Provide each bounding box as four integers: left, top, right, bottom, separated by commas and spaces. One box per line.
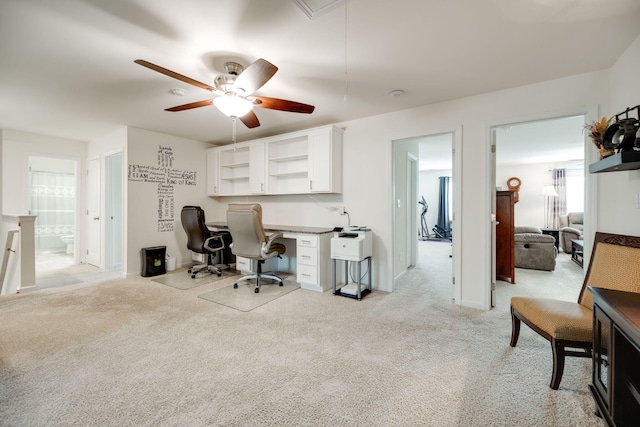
0, 0, 640, 143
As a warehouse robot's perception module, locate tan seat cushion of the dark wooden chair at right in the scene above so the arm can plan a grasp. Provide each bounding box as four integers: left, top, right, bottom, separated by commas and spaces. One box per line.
511, 297, 593, 342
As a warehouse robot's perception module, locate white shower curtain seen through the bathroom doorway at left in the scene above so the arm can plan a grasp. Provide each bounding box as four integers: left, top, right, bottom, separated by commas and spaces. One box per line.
29, 171, 76, 249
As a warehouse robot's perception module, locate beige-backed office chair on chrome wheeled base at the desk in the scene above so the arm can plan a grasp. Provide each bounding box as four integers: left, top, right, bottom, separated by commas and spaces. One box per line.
227, 203, 286, 293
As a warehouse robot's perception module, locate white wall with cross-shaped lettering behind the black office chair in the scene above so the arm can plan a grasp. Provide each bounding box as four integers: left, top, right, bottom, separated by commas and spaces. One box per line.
124, 127, 214, 275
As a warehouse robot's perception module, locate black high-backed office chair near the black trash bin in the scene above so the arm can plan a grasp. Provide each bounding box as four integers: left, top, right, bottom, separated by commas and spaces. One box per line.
180, 206, 231, 279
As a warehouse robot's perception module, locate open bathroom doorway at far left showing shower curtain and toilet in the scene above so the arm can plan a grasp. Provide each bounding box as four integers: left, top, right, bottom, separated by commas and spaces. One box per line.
28, 156, 78, 276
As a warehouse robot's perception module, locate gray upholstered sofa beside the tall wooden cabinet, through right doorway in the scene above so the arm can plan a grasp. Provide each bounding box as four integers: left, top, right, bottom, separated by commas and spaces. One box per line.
514, 226, 558, 271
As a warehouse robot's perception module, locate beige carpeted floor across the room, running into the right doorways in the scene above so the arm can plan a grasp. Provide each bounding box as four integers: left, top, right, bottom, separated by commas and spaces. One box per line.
0, 242, 603, 426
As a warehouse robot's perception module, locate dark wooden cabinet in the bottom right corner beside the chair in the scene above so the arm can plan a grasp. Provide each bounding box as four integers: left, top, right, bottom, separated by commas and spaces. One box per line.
589, 287, 640, 427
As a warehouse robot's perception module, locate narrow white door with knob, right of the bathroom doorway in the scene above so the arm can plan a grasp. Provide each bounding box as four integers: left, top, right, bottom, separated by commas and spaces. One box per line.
85, 158, 100, 267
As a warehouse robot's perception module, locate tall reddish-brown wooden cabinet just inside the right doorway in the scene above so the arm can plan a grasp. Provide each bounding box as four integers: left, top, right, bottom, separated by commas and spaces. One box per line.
496, 191, 516, 283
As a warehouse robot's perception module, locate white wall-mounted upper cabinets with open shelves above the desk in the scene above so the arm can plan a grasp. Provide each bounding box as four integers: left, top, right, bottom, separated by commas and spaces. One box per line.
208, 126, 343, 196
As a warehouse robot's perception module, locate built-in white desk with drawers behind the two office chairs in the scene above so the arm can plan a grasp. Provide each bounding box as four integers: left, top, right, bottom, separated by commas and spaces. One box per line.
206, 221, 333, 292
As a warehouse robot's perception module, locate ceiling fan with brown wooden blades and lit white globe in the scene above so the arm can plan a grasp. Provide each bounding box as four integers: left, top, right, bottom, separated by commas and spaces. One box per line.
133, 58, 315, 128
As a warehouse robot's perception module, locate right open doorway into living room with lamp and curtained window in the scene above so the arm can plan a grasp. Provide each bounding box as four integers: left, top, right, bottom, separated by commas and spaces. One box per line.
491, 114, 586, 306
